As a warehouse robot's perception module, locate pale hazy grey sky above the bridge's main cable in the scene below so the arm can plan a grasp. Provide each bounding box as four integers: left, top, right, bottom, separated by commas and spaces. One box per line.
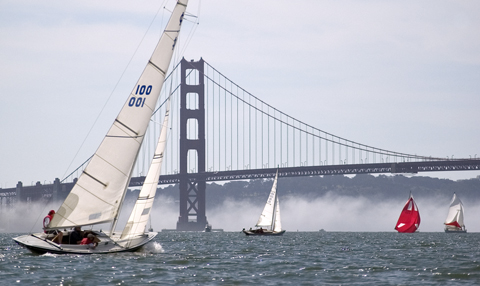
0, 0, 480, 188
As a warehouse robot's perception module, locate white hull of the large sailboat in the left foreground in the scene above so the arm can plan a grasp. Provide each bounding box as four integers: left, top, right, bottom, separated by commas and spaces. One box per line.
13, 232, 157, 254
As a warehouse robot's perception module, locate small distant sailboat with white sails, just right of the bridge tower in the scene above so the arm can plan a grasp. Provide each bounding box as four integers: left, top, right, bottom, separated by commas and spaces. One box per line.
242, 170, 285, 235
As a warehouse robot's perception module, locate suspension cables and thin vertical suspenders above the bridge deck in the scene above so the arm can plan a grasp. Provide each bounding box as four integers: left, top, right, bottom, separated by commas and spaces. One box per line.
64, 58, 445, 183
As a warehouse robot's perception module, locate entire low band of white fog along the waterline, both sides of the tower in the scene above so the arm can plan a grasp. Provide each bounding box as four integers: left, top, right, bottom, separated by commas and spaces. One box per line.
0, 193, 480, 232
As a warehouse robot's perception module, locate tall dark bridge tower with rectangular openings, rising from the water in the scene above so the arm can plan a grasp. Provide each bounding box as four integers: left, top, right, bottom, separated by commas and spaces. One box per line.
177, 59, 207, 231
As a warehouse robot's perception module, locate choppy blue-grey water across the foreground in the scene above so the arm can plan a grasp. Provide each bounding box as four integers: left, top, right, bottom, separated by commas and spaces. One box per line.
0, 231, 480, 285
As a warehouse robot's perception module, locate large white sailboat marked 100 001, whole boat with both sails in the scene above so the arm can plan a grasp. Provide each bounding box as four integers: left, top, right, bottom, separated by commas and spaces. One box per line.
14, 0, 188, 254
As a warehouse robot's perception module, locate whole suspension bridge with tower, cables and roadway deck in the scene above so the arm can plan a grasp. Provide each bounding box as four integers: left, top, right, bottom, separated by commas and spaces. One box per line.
0, 59, 480, 230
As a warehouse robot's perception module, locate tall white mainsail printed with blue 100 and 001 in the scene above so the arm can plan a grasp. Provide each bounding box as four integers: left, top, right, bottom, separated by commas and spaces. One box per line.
50, 0, 188, 228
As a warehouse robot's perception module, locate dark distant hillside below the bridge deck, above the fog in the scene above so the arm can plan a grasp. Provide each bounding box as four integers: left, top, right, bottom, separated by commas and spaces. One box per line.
141, 175, 480, 208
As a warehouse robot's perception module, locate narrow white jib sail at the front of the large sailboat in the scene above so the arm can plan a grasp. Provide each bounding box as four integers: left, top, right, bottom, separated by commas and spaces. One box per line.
120, 99, 170, 239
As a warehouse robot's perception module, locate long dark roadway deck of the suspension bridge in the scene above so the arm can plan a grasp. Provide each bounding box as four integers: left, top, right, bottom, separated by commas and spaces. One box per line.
130, 159, 480, 187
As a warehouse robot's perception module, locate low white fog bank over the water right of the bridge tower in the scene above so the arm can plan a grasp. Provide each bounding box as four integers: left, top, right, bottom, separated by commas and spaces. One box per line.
207, 193, 480, 232
